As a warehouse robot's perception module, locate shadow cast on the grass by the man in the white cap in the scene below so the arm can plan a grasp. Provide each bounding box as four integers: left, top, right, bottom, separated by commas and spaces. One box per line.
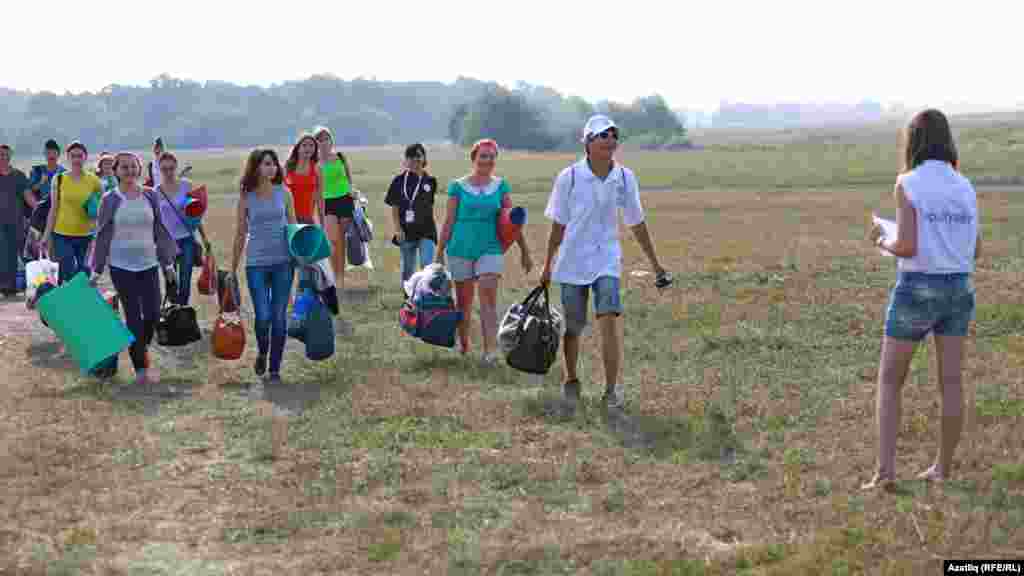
519, 393, 742, 464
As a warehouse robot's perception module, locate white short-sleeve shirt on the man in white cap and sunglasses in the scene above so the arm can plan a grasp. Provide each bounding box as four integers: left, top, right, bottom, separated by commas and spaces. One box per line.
544, 159, 644, 286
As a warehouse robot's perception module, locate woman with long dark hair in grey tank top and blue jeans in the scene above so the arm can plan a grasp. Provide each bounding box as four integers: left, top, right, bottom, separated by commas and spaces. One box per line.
231, 149, 295, 383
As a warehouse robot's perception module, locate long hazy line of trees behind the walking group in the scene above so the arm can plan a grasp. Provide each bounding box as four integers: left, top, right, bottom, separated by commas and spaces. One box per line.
0, 75, 685, 154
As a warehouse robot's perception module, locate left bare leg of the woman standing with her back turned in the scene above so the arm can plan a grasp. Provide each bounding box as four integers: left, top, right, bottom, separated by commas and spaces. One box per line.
863, 336, 916, 489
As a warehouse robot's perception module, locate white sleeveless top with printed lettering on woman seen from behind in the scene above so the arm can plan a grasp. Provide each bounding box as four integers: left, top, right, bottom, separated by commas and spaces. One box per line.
898, 160, 978, 274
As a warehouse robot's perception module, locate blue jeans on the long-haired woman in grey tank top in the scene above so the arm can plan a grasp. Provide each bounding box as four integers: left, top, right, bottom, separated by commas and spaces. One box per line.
246, 262, 295, 374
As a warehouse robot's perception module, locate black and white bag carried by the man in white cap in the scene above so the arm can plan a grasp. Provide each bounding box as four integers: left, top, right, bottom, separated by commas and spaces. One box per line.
498, 285, 562, 374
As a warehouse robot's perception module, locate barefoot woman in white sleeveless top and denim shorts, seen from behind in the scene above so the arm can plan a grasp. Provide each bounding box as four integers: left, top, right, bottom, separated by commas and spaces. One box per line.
864, 110, 980, 489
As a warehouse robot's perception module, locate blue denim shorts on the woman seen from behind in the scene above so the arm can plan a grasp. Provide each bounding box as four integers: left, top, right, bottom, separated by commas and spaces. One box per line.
886, 272, 975, 342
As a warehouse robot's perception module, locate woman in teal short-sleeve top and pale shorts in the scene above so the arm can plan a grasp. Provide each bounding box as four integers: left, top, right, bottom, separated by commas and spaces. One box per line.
435, 139, 534, 365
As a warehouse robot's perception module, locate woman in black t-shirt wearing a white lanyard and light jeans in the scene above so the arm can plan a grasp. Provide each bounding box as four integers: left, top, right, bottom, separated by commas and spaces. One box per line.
384, 143, 437, 286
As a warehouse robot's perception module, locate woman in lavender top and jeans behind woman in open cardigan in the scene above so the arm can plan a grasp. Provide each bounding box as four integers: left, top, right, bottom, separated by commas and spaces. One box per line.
156, 152, 210, 306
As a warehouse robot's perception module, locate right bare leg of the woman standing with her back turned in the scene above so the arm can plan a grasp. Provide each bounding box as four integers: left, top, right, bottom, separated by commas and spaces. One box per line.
918, 335, 964, 481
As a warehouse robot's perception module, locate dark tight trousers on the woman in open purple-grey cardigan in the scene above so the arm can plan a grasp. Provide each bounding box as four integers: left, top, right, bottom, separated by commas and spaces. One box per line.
111, 266, 160, 372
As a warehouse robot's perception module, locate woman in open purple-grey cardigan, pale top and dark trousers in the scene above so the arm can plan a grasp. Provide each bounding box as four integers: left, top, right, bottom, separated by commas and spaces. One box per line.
90, 153, 177, 385
